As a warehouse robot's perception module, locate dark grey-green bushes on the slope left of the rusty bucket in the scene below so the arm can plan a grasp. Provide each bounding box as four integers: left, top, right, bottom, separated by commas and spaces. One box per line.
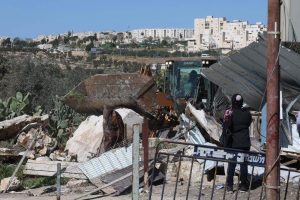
0, 57, 100, 113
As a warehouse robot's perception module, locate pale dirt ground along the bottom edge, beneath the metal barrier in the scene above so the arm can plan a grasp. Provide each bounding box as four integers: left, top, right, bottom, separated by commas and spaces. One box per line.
0, 182, 299, 200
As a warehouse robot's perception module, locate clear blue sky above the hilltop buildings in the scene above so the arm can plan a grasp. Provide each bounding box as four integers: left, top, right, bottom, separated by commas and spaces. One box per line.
0, 0, 267, 38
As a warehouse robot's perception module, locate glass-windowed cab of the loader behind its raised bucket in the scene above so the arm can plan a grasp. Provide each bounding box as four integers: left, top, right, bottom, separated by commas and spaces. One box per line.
164, 60, 217, 113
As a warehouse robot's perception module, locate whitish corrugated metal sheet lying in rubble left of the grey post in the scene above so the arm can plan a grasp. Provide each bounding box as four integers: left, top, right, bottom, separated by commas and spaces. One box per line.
79, 145, 132, 179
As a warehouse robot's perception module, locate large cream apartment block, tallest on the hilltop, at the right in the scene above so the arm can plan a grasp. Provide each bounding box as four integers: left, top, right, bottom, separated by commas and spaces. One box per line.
192, 16, 266, 51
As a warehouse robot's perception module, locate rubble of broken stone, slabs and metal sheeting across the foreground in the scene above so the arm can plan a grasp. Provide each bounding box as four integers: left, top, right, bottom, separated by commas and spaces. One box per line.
0, 104, 300, 199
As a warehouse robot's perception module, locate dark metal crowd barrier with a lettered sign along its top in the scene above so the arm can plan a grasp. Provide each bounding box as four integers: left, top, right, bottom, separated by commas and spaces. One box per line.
149, 141, 300, 200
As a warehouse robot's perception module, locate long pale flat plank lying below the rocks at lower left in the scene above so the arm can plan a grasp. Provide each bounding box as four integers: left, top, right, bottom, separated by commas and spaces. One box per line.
23, 160, 87, 179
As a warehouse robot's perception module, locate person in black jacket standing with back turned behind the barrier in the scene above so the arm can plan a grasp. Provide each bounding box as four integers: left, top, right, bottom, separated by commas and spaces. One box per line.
223, 94, 252, 192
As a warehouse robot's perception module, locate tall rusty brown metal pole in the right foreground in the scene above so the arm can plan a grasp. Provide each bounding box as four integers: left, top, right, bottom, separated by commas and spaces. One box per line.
265, 0, 280, 200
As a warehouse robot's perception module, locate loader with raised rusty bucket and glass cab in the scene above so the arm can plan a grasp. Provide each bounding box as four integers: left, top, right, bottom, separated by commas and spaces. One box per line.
63, 57, 217, 148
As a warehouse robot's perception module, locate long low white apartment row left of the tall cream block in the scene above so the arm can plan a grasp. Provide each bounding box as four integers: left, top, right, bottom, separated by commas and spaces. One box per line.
130, 28, 194, 42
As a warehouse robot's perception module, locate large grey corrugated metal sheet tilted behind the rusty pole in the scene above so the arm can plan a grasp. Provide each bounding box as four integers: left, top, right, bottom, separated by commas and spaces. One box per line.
202, 35, 300, 109
